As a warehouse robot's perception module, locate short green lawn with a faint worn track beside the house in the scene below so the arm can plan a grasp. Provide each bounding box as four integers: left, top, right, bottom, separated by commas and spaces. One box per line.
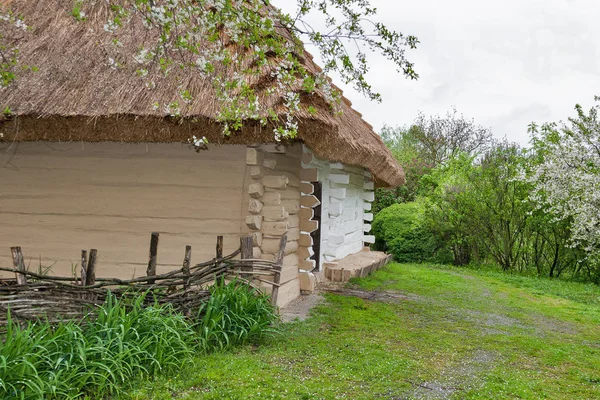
122, 264, 600, 399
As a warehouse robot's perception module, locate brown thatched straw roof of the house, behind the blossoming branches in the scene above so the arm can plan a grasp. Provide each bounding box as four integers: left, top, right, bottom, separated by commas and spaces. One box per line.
0, 0, 404, 187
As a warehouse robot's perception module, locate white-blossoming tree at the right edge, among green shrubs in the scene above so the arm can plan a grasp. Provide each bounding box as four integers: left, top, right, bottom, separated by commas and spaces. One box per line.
526, 97, 600, 260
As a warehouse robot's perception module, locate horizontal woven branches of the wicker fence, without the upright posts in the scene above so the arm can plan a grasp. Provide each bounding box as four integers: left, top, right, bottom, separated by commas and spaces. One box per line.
0, 244, 281, 326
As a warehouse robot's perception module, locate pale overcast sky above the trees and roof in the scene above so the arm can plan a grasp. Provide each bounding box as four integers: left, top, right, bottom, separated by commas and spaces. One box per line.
279, 0, 600, 144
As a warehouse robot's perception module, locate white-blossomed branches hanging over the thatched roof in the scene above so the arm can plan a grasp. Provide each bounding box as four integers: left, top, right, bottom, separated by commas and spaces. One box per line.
0, 0, 418, 139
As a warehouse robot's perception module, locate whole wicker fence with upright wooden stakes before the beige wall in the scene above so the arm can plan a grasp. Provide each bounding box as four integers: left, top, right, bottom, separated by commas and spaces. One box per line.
0, 233, 287, 325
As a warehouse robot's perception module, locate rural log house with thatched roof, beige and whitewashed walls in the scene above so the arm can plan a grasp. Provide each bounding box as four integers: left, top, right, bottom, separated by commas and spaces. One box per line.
0, 0, 404, 305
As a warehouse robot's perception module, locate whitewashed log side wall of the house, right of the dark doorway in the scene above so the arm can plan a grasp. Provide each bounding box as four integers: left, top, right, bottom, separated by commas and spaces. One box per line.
302, 146, 374, 265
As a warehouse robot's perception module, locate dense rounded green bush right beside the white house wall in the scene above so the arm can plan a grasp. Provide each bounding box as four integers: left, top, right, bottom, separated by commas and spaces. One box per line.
372, 202, 452, 263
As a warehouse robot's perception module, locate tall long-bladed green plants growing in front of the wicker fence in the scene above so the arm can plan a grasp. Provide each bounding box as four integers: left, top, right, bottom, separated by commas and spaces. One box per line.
0, 282, 277, 399
